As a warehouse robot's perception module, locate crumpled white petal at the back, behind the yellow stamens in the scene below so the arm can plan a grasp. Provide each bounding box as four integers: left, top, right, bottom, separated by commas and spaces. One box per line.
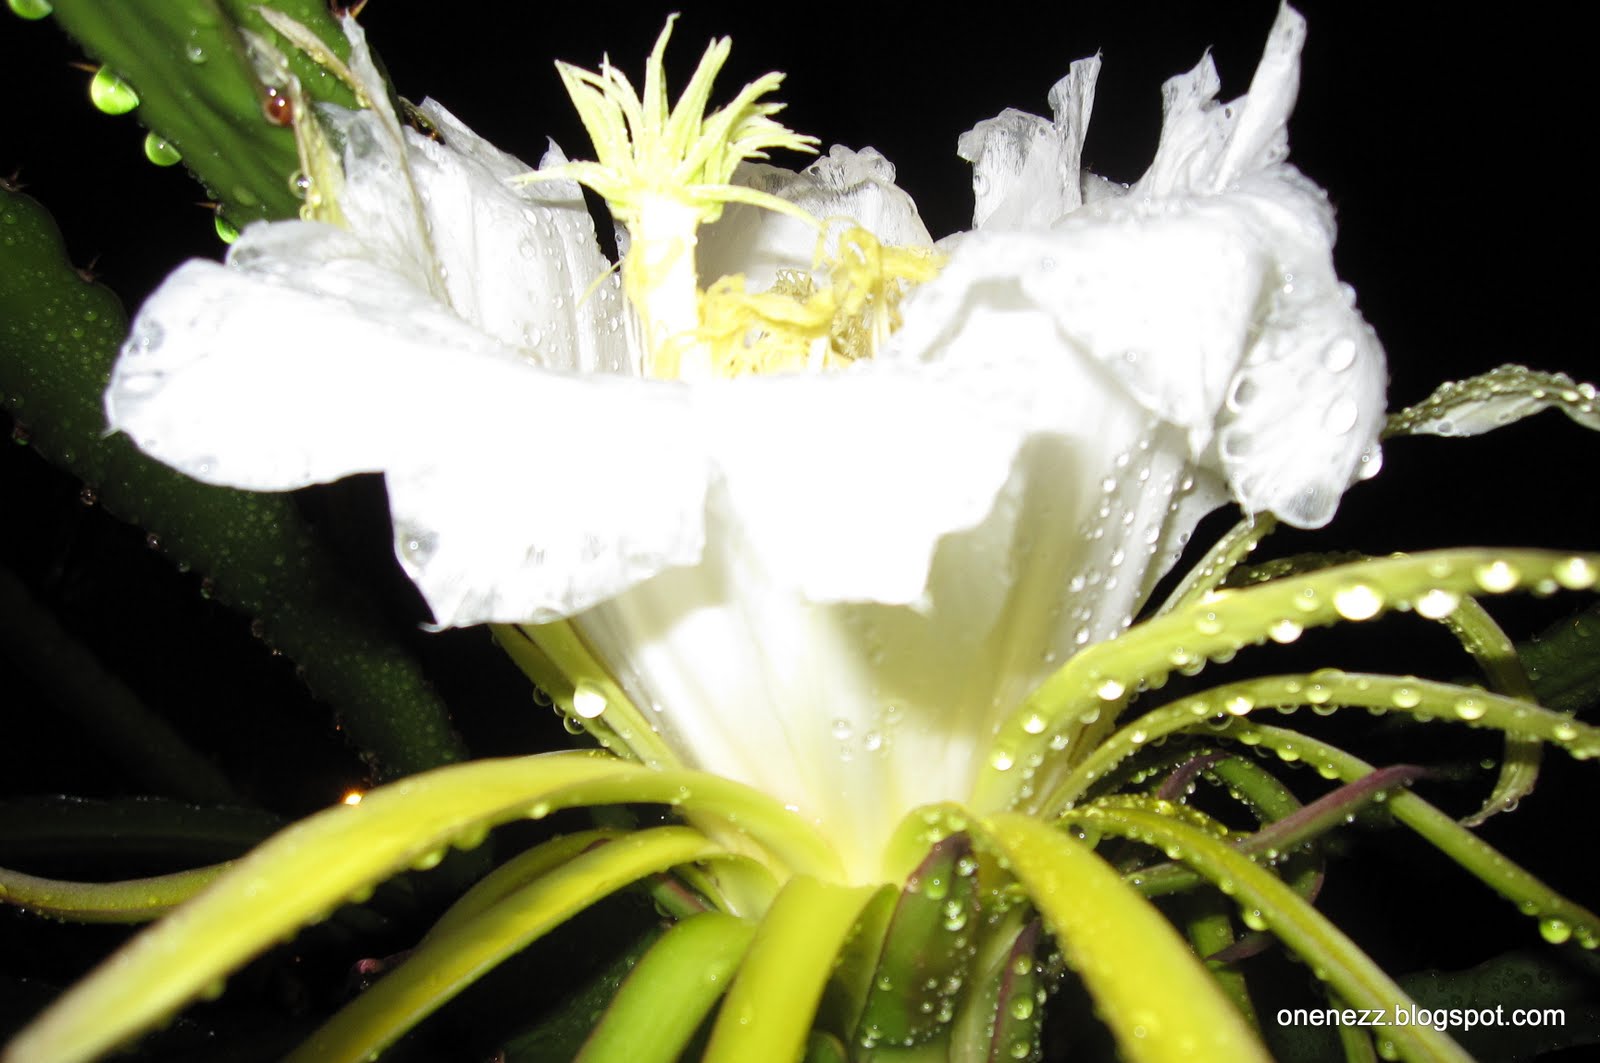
696, 146, 933, 291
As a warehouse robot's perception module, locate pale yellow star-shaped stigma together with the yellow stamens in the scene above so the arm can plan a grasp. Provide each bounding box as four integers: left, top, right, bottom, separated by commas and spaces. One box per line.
525, 16, 938, 379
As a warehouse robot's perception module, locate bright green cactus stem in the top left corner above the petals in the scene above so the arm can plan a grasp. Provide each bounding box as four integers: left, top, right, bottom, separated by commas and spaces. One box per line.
45, 0, 355, 227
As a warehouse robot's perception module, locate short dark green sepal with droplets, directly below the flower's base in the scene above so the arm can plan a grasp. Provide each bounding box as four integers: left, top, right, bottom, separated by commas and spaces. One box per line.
854, 834, 979, 1049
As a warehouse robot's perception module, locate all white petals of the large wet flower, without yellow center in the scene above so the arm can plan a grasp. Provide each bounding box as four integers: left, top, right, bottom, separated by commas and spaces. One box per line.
107, 8, 1384, 880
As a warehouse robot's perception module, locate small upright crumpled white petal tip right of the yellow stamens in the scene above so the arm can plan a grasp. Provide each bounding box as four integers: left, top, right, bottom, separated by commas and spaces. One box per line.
955, 56, 1101, 229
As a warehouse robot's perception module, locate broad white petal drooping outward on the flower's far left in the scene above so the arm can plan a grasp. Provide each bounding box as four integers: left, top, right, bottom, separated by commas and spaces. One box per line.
106, 223, 707, 624
